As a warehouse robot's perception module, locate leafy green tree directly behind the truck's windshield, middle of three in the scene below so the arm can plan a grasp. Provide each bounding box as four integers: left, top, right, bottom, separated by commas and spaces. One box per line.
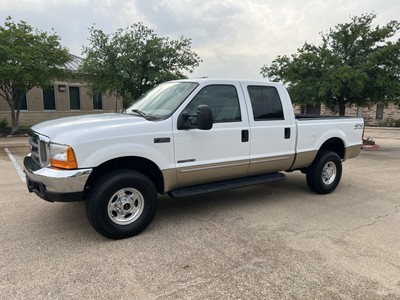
81, 23, 201, 107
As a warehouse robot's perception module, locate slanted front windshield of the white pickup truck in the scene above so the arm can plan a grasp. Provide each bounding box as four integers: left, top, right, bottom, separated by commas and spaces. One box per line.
126, 82, 198, 119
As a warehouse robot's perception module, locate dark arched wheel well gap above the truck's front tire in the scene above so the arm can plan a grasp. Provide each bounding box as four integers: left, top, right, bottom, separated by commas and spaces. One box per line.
85, 157, 164, 194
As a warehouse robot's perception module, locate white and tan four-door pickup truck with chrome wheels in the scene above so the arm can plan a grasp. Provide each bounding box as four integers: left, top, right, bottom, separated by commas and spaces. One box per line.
24, 79, 364, 239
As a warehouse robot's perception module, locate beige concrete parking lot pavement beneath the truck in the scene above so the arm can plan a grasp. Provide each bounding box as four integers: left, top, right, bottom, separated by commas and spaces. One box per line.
0, 128, 400, 300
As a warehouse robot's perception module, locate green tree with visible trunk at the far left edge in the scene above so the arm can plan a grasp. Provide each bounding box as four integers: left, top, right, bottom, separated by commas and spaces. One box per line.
0, 17, 71, 134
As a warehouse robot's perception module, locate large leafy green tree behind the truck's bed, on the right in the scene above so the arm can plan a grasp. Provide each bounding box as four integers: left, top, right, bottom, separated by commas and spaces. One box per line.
261, 14, 400, 115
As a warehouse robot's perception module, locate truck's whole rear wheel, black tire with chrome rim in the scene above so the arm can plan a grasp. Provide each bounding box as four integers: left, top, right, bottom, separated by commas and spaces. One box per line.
306, 150, 342, 194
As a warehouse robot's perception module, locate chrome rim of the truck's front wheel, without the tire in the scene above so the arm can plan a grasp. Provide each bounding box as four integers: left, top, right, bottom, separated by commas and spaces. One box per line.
107, 188, 144, 225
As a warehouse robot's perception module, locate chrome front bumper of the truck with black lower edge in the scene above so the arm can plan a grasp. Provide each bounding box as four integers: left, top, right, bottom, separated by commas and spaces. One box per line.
24, 154, 92, 202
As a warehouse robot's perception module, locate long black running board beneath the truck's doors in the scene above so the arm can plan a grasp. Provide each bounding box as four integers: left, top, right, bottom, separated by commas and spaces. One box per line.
169, 173, 286, 197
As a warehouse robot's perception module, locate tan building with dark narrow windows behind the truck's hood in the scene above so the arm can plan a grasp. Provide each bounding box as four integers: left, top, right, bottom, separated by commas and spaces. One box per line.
0, 56, 122, 127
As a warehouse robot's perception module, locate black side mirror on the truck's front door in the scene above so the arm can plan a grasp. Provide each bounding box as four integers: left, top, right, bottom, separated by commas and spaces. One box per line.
177, 105, 213, 130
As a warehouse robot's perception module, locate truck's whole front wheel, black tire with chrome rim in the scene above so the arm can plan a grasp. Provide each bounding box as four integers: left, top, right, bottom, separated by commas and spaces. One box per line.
86, 170, 157, 239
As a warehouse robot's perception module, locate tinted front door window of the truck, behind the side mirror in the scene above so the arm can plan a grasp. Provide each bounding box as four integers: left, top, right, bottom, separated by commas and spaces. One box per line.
186, 85, 242, 123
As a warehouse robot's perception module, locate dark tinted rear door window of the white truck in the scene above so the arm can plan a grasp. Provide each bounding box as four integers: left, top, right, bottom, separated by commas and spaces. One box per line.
247, 86, 284, 121
